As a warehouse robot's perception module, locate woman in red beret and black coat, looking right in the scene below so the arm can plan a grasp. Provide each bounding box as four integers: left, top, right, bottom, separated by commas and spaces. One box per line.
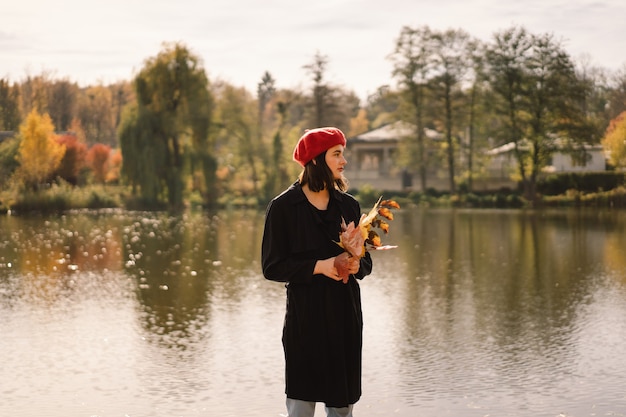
261, 127, 372, 417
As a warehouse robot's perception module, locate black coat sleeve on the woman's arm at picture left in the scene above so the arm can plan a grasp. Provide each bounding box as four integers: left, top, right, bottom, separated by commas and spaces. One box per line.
261, 200, 317, 283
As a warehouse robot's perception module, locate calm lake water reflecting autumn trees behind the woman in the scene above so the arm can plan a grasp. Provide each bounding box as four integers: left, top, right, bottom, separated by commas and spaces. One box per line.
0, 209, 626, 417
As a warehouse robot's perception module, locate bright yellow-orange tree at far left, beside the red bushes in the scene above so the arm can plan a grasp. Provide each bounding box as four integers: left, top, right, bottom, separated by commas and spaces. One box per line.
17, 110, 65, 185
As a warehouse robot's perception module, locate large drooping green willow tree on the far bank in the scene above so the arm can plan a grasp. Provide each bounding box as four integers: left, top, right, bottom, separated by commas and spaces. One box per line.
119, 43, 216, 209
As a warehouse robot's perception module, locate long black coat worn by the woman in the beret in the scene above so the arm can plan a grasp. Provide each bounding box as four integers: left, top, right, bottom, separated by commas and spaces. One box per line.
261, 182, 372, 407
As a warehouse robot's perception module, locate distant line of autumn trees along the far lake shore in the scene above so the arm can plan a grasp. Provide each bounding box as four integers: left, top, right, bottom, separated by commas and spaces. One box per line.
0, 26, 626, 209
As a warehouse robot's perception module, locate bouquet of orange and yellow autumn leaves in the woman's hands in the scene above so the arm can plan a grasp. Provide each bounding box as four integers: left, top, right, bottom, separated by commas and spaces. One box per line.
335, 196, 400, 283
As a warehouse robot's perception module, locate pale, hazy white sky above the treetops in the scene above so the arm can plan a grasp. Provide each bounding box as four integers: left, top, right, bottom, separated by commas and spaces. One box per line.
0, 0, 626, 99
